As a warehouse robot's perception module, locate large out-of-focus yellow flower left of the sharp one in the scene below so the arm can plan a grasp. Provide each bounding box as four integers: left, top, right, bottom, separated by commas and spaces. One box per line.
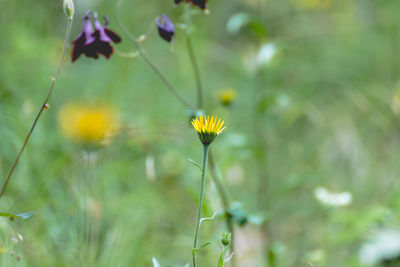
59, 104, 118, 143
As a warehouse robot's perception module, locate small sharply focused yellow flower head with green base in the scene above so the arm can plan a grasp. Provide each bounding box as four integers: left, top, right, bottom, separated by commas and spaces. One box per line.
192, 116, 226, 145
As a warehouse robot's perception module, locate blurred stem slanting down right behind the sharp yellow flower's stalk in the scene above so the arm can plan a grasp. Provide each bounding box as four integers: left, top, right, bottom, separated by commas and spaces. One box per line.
208, 149, 236, 267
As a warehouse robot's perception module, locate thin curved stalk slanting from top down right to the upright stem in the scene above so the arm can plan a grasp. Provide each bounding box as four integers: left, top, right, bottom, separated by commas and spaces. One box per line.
115, 3, 195, 110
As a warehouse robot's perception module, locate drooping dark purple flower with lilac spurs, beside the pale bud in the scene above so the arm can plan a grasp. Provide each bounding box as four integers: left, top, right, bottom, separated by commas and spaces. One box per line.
72, 11, 121, 62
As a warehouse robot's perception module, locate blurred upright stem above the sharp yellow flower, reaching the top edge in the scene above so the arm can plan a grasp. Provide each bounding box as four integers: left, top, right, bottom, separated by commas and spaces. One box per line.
185, 4, 203, 109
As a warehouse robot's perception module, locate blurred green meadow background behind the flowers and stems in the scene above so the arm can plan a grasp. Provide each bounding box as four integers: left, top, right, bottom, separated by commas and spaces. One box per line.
0, 0, 400, 267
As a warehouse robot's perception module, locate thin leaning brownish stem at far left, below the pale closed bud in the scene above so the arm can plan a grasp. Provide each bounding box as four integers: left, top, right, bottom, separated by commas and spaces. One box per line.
0, 17, 72, 197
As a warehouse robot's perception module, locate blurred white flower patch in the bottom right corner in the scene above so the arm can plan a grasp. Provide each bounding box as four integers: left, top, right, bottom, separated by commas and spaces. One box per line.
359, 229, 400, 264
